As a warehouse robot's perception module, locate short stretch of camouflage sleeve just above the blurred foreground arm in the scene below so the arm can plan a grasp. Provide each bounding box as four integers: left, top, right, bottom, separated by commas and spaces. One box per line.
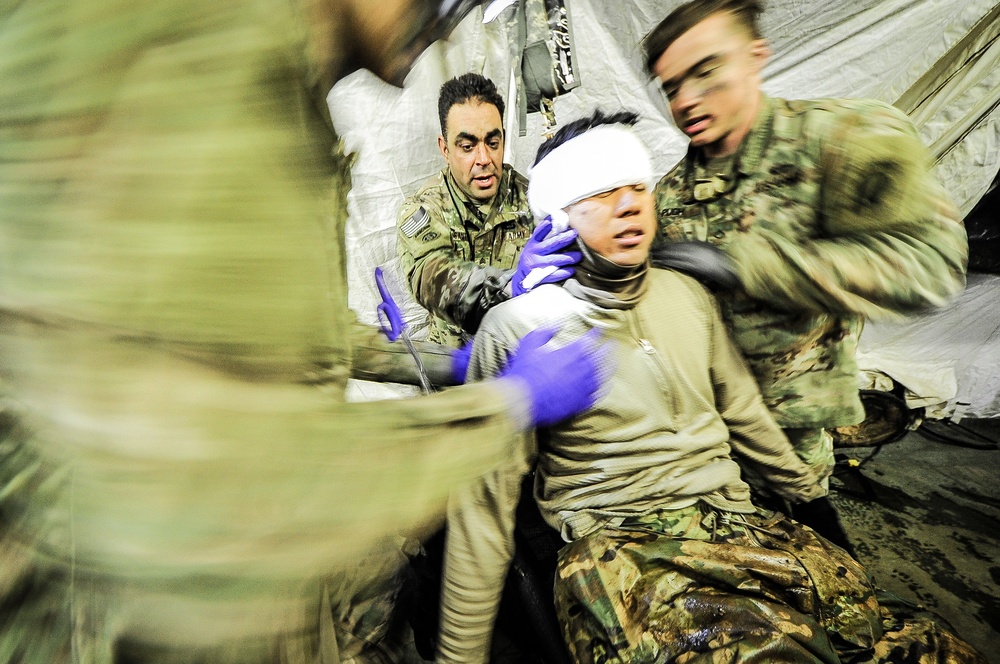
351, 323, 458, 387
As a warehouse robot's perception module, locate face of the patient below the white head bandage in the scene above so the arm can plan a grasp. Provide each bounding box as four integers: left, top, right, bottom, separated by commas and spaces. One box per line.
566, 184, 656, 265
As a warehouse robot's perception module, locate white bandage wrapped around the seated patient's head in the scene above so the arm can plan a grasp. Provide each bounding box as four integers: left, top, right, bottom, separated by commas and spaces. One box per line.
528, 124, 654, 232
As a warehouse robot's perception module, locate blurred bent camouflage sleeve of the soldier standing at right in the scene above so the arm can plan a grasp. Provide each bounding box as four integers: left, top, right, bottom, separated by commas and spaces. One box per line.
732, 102, 968, 317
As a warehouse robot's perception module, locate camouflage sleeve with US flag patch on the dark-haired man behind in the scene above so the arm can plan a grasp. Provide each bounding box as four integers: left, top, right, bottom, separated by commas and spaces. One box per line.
396, 195, 514, 334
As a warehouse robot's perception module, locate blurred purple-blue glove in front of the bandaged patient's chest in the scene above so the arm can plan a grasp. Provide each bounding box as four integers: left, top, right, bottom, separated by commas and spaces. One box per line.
501, 329, 611, 427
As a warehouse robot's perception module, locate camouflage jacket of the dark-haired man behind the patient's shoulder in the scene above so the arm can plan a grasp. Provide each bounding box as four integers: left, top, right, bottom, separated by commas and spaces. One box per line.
397, 164, 534, 347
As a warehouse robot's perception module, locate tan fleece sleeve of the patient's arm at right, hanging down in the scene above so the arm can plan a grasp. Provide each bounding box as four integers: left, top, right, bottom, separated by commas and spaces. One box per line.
710, 290, 823, 503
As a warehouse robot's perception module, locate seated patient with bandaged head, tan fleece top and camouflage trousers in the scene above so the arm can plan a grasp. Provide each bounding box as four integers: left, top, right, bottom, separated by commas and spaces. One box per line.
437, 112, 981, 662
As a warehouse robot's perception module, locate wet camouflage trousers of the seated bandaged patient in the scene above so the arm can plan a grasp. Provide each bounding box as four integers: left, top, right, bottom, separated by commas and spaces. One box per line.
555, 506, 985, 664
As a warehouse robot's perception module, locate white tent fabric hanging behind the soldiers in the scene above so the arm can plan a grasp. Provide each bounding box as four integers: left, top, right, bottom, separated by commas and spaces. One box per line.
328, 0, 1000, 416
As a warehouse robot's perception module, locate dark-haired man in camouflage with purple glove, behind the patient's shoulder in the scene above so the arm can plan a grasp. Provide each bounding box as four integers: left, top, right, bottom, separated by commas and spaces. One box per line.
397, 73, 579, 347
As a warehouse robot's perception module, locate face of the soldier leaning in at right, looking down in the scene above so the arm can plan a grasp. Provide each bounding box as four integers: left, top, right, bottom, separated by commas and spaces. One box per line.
653, 12, 770, 157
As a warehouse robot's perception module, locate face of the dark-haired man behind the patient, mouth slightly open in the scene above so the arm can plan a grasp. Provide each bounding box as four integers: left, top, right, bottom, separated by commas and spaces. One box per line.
438, 101, 503, 202
